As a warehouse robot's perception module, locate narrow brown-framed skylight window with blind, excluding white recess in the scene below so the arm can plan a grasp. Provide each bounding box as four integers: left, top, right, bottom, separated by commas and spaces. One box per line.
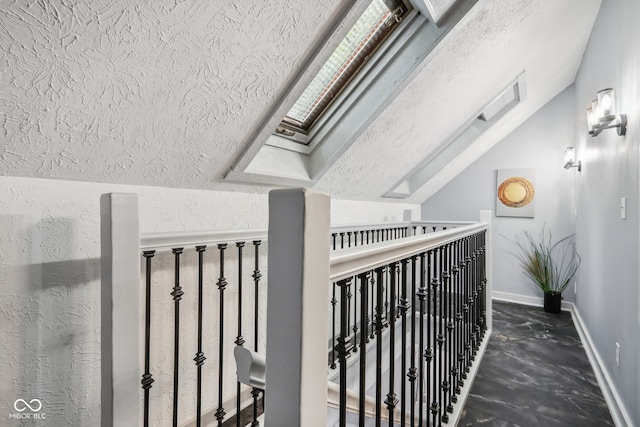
276, 0, 408, 144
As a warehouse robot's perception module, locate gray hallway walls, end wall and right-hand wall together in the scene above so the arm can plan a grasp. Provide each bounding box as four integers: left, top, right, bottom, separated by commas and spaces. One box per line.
422, 0, 640, 425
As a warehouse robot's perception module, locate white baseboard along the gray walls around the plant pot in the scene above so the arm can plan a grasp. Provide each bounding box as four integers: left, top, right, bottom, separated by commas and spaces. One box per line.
491, 291, 633, 427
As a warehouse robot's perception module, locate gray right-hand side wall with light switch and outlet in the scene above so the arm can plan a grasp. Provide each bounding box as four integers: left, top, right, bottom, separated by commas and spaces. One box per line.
575, 0, 640, 426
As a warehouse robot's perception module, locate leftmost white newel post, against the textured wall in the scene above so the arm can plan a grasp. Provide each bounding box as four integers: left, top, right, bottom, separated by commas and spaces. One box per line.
100, 193, 142, 427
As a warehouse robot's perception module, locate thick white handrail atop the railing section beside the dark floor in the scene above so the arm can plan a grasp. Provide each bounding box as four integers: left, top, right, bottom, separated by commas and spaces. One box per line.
329, 222, 488, 282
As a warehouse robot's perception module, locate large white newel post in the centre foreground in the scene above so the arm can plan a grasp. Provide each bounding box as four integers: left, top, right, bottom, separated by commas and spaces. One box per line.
265, 189, 330, 427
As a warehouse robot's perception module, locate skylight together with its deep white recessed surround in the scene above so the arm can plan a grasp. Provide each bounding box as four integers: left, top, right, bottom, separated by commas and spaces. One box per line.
225, 0, 478, 187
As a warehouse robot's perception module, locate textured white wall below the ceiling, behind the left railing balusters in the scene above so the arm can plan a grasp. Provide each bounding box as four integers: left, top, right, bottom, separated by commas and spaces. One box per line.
0, 177, 417, 426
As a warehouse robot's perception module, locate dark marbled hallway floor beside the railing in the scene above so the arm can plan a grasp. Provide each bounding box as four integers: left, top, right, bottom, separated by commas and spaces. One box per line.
458, 302, 614, 427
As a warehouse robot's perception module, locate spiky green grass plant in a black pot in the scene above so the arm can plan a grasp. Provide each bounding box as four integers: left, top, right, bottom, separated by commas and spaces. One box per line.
514, 226, 580, 313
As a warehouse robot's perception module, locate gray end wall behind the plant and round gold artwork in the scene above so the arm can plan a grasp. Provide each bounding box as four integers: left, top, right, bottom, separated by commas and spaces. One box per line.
422, 86, 578, 300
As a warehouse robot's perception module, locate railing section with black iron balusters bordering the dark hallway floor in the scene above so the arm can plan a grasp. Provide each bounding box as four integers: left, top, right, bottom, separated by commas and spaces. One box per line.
328, 217, 491, 426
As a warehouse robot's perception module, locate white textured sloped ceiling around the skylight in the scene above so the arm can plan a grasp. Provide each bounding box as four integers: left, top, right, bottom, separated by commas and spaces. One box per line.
0, 0, 600, 202
